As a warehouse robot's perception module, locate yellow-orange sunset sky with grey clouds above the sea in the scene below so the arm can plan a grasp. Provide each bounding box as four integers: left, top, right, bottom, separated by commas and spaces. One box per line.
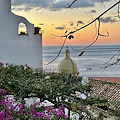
12, 0, 120, 46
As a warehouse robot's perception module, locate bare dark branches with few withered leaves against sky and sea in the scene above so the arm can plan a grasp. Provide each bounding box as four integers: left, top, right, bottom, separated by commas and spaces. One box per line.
46, 0, 120, 69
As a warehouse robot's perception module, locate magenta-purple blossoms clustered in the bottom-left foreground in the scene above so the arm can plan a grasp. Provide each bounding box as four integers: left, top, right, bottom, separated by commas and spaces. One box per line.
0, 89, 67, 120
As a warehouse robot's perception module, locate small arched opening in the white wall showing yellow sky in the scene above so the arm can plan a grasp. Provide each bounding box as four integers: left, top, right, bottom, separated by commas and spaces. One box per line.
18, 22, 27, 35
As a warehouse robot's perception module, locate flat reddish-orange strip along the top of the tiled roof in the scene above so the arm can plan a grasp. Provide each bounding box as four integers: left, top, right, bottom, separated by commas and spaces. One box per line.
89, 77, 120, 84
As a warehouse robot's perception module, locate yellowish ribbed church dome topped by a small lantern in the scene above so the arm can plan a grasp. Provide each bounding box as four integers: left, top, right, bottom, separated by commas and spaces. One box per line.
57, 49, 79, 74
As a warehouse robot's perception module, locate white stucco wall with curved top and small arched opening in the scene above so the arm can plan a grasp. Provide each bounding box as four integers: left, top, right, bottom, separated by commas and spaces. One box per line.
0, 0, 43, 68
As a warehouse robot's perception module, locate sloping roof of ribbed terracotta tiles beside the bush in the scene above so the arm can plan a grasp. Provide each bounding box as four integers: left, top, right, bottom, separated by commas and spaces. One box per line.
90, 77, 120, 109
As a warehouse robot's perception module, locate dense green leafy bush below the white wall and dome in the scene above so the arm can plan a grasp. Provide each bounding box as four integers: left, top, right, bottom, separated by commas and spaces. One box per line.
0, 64, 106, 120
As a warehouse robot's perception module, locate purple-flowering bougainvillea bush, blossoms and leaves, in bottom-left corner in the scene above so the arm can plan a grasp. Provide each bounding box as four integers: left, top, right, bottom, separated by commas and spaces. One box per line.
0, 89, 67, 120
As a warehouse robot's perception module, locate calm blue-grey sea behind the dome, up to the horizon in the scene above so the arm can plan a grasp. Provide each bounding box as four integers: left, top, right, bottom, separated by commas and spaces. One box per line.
43, 45, 120, 77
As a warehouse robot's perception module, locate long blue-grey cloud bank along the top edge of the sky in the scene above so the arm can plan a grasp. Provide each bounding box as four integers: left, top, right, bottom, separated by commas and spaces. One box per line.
12, 0, 94, 11
